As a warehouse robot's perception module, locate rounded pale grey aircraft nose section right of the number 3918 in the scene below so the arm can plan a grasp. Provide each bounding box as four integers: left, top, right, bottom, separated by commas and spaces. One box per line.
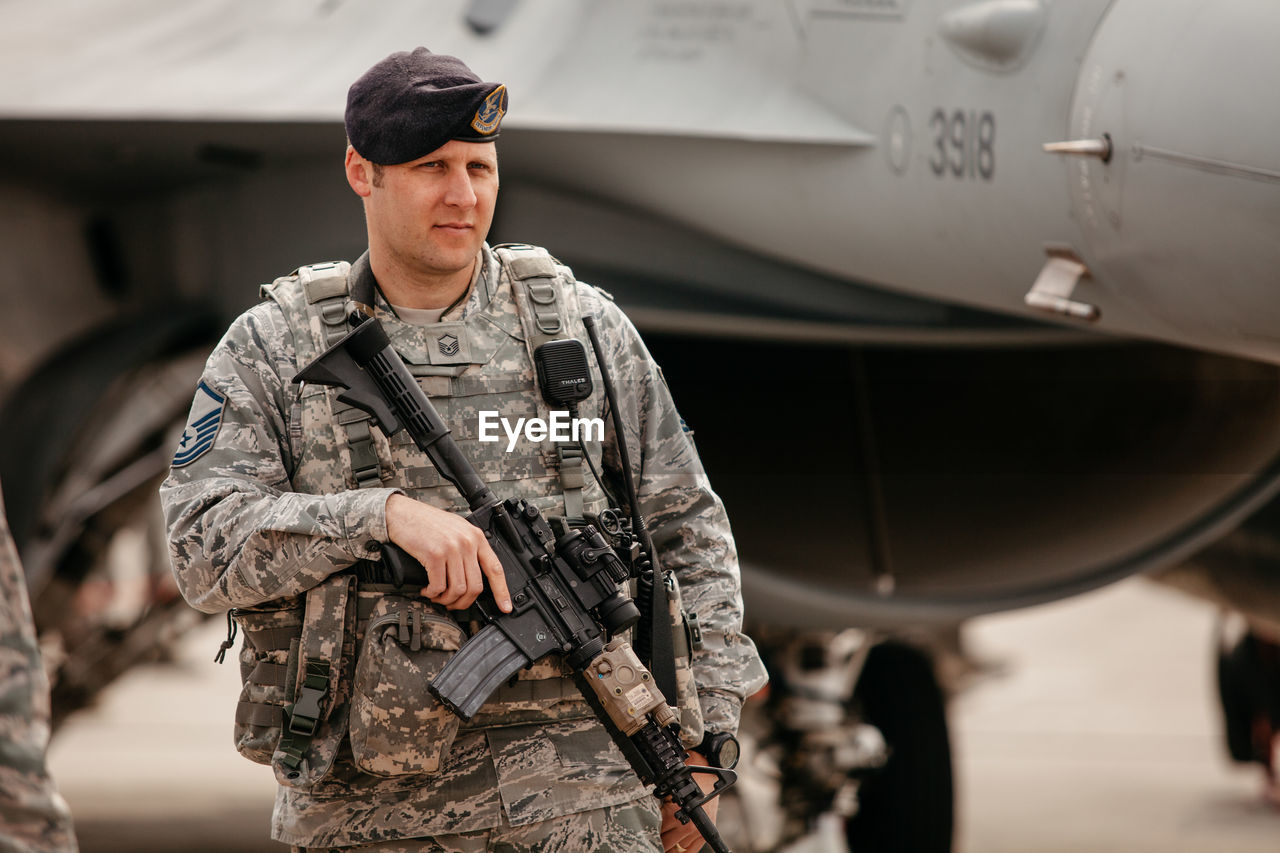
1064, 0, 1280, 360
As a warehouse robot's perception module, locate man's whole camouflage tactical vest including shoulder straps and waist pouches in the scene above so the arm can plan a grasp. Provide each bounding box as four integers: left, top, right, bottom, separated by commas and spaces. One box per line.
237, 246, 701, 788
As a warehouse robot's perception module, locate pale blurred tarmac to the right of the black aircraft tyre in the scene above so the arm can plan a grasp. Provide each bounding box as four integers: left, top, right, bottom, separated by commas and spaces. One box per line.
951, 579, 1280, 853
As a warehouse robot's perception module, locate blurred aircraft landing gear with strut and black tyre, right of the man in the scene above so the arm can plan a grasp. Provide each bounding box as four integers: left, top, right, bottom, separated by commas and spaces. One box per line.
719, 629, 954, 853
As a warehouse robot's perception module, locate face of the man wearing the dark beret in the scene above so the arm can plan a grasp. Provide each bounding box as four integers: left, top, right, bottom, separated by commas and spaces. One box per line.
348, 140, 498, 277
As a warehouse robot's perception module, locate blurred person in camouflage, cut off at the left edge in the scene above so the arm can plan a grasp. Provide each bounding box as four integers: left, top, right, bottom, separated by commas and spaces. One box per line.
0, 481, 77, 853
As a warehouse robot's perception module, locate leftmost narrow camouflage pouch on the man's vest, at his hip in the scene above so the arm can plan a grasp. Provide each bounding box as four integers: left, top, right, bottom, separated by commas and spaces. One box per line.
232, 605, 302, 765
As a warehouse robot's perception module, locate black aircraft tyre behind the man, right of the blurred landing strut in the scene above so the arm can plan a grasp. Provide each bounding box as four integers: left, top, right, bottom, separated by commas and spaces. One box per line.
846, 642, 955, 853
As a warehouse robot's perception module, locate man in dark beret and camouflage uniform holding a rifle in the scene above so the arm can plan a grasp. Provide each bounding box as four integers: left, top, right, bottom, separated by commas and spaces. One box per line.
161, 49, 765, 853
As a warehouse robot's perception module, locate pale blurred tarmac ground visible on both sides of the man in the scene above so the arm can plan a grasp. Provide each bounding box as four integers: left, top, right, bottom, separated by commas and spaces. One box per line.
50, 579, 1280, 853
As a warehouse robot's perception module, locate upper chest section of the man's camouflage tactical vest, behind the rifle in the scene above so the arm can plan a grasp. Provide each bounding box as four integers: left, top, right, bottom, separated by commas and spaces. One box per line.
282, 246, 607, 525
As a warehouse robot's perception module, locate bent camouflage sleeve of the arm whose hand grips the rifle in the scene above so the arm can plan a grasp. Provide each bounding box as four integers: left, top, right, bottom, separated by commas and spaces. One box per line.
160, 302, 397, 612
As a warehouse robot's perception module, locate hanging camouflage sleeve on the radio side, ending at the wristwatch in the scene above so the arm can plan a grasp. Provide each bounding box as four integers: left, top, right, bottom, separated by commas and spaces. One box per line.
580, 288, 768, 731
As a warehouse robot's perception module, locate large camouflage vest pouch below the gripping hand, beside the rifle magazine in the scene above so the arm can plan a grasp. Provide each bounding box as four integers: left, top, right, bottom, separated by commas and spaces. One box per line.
351, 594, 463, 776
